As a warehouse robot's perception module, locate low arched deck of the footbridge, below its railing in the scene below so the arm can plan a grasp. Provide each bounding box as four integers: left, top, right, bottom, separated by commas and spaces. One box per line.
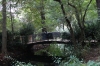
27, 40, 72, 50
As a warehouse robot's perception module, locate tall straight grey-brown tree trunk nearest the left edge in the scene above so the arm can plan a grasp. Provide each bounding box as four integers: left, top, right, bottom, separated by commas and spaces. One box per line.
2, 0, 7, 55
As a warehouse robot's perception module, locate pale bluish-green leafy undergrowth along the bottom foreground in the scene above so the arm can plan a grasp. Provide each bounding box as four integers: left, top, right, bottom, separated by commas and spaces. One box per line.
13, 56, 100, 66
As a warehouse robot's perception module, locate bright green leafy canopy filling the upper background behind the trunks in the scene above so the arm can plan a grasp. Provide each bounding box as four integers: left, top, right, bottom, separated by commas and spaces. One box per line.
3, 0, 97, 32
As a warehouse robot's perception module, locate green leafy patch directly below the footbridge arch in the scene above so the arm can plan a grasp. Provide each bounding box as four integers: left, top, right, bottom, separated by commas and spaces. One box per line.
35, 44, 63, 56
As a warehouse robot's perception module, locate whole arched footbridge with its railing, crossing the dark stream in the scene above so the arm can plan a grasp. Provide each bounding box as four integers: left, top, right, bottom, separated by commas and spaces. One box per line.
27, 32, 95, 49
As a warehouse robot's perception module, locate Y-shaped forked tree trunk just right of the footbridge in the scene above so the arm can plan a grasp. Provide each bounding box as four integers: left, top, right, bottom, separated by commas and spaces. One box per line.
68, 0, 92, 44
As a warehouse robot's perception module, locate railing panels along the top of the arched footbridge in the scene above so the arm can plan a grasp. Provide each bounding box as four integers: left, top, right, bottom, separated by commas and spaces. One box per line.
20, 32, 62, 44
